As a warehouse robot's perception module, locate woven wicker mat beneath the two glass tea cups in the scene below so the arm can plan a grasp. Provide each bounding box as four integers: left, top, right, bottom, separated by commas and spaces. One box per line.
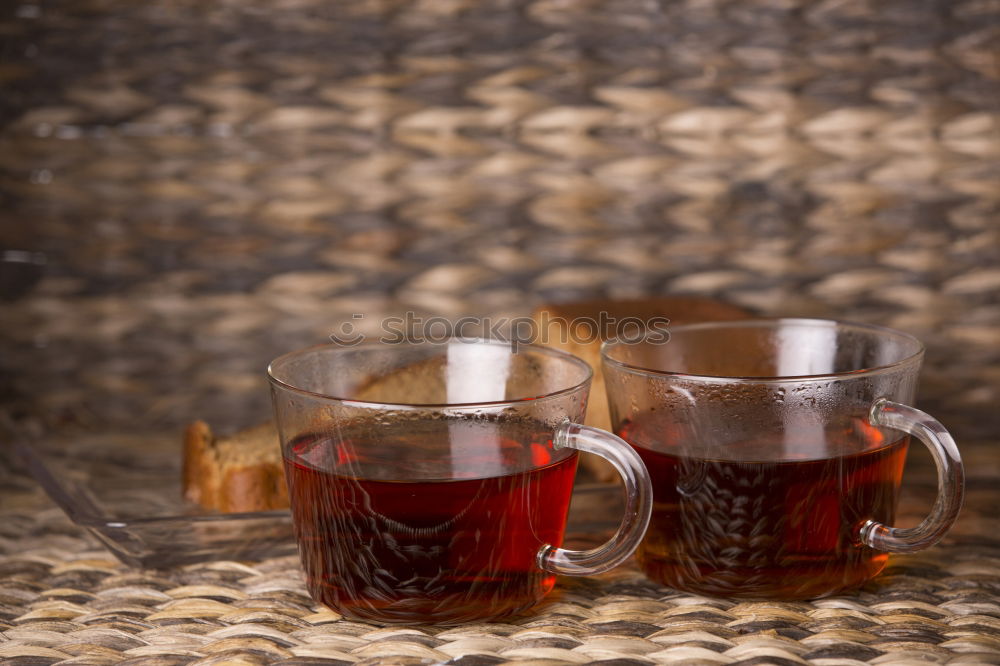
0, 442, 1000, 666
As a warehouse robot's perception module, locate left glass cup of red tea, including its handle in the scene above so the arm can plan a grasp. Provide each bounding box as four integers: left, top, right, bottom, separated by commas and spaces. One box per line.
268, 340, 651, 623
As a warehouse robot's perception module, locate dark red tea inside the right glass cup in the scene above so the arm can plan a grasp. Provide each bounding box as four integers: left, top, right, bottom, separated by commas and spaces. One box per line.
620, 420, 909, 599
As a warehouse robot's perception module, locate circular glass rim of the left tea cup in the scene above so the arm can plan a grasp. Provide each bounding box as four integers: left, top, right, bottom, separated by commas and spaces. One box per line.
267, 336, 594, 410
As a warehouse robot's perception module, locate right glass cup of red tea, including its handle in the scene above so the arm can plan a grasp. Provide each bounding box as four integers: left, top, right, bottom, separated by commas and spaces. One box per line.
602, 319, 964, 599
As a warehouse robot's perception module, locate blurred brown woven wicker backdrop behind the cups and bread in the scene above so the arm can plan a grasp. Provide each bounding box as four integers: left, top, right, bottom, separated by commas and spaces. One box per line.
0, 0, 1000, 428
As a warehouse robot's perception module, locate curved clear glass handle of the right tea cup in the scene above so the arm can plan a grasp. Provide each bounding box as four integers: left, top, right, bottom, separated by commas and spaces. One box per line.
861, 398, 965, 553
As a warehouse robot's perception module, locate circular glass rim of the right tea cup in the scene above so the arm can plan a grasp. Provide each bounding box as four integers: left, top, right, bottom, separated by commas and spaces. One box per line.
601, 317, 925, 384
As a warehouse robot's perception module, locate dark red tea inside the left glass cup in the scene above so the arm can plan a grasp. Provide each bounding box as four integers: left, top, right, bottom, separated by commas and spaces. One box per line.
285, 419, 577, 623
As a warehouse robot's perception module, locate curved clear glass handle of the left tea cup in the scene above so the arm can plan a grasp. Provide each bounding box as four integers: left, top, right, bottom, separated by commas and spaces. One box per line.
537, 421, 653, 576
